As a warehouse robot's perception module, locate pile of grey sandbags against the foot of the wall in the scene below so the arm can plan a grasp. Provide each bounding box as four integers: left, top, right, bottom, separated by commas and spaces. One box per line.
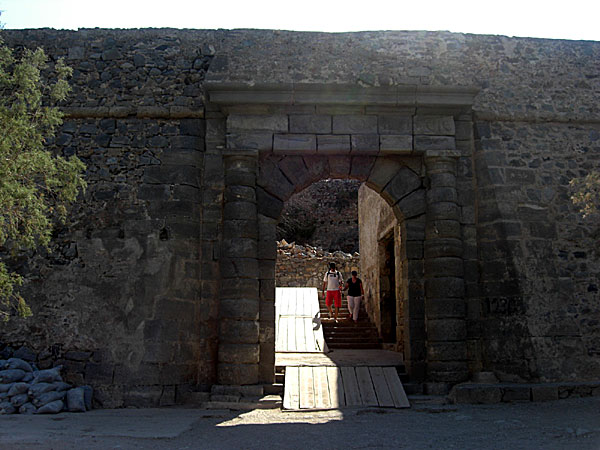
0, 358, 93, 414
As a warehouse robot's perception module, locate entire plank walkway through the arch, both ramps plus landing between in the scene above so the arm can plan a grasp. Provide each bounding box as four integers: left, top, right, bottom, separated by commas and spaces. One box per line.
275, 288, 410, 410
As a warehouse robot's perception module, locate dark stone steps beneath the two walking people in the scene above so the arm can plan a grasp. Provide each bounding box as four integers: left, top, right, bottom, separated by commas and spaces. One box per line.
320, 297, 382, 350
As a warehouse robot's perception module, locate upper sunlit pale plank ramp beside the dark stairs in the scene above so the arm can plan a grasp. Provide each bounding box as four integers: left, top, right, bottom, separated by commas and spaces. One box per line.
275, 287, 327, 353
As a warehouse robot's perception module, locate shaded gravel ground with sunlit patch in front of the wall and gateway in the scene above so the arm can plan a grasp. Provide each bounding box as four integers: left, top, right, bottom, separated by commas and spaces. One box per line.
0, 397, 600, 450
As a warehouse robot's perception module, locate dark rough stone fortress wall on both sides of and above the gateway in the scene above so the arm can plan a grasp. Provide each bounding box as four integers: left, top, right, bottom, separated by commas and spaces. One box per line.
0, 29, 600, 407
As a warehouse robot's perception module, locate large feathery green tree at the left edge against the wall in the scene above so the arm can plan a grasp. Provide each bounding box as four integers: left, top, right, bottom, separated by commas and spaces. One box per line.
0, 37, 86, 320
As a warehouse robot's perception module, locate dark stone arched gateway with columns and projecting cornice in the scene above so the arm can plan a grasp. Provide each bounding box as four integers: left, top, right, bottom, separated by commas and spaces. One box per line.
206, 83, 477, 385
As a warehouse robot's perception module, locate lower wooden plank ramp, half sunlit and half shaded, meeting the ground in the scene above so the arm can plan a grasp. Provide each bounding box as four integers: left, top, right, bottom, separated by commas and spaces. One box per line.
283, 366, 410, 410
